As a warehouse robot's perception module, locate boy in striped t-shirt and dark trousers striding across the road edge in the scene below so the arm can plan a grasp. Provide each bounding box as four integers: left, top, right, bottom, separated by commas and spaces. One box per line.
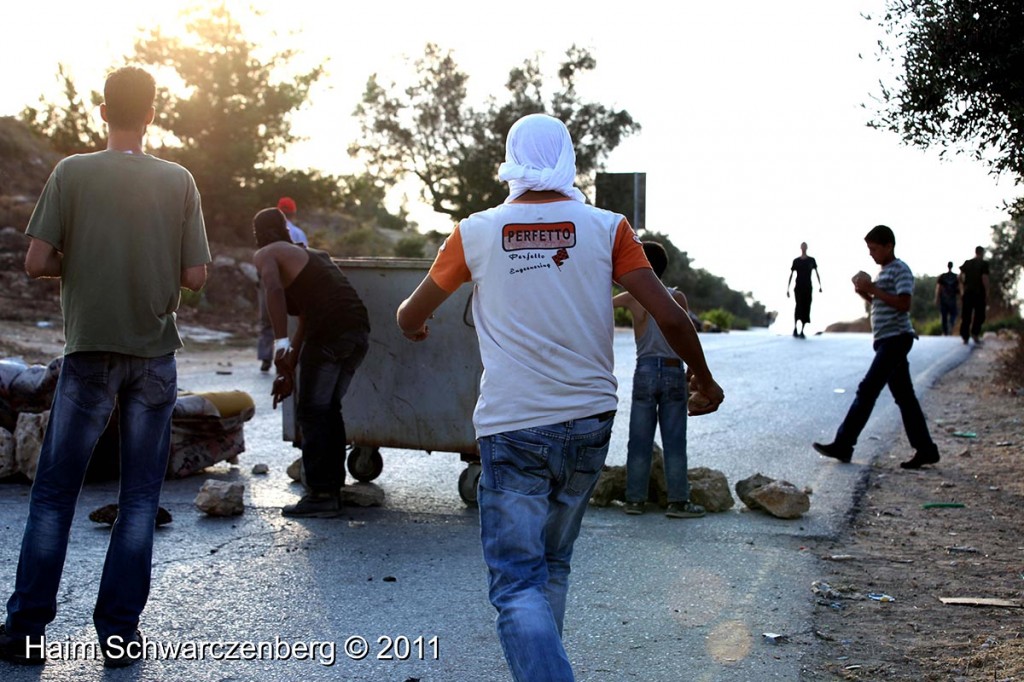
813, 225, 939, 469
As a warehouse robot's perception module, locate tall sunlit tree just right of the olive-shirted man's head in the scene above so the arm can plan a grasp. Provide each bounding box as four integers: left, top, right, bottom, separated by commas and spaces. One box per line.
134, 4, 324, 241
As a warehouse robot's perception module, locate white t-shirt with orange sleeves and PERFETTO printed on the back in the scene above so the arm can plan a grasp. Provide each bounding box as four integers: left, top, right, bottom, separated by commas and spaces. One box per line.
430, 192, 650, 437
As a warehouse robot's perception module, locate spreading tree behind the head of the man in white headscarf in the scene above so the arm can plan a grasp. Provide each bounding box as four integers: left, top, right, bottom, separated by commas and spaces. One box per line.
349, 44, 640, 220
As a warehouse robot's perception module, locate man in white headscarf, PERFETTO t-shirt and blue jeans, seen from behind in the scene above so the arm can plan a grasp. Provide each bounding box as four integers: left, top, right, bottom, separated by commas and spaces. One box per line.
397, 114, 724, 682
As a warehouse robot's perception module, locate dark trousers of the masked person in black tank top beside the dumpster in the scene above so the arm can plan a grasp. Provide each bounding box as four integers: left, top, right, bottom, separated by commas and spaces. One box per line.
295, 335, 367, 495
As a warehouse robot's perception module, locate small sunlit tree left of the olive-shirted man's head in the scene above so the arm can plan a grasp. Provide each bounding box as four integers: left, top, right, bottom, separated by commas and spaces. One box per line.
19, 63, 106, 155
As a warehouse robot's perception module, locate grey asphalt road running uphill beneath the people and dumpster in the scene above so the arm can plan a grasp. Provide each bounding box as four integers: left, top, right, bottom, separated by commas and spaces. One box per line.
0, 332, 969, 682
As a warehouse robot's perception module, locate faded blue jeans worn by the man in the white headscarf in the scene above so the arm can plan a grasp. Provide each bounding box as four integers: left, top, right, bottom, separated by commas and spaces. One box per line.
477, 414, 614, 682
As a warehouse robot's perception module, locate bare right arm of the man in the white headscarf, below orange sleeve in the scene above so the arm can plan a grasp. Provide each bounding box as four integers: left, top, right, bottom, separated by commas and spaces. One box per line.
620, 268, 725, 414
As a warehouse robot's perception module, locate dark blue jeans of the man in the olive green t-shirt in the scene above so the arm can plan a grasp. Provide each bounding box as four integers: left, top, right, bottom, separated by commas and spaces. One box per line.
6, 352, 177, 641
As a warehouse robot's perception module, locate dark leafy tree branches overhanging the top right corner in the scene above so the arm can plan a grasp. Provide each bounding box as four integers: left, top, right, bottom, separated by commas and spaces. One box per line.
872, 0, 1024, 181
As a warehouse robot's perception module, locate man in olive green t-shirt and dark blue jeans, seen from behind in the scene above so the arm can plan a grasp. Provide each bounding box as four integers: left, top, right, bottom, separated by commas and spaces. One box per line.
0, 67, 210, 667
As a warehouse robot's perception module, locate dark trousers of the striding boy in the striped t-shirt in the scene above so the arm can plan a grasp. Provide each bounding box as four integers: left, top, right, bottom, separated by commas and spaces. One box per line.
836, 334, 935, 453
